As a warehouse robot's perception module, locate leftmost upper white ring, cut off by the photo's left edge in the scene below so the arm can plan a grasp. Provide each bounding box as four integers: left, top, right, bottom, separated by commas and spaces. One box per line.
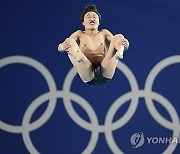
0, 56, 56, 133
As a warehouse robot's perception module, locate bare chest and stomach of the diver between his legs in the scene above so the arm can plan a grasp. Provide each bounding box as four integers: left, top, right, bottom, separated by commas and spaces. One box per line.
75, 30, 107, 65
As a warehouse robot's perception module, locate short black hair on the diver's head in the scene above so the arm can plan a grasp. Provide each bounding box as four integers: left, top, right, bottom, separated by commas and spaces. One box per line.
80, 4, 101, 22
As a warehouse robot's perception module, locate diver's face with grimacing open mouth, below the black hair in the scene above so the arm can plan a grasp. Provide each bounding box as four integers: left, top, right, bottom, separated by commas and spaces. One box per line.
82, 12, 99, 30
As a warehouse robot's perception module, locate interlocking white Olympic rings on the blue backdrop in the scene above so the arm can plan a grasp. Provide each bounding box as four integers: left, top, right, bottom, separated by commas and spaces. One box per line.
0, 55, 180, 154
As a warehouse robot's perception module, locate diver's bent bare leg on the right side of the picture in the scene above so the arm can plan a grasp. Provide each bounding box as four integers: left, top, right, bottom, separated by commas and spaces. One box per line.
101, 34, 124, 79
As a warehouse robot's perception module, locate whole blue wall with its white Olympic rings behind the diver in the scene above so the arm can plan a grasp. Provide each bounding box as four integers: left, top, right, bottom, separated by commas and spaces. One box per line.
0, 0, 180, 154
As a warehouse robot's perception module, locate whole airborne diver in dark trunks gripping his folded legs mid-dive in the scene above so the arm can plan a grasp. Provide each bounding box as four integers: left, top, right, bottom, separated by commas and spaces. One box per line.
58, 5, 129, 85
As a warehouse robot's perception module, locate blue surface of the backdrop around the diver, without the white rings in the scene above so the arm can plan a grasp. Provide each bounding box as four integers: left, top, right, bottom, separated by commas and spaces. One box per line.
0, 0, 180, 154
